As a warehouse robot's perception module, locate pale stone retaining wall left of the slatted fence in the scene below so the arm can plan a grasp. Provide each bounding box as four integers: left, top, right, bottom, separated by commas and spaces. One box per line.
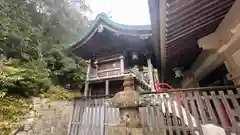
13, 98, 72, 135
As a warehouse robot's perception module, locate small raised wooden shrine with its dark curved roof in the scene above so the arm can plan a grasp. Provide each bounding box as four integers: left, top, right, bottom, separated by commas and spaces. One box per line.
70, 13, 160, 96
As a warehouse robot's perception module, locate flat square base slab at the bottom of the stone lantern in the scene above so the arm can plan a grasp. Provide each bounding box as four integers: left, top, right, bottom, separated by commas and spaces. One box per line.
108, 126, 143, 135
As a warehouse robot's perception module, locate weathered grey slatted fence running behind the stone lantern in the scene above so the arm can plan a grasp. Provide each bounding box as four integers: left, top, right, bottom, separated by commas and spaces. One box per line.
68, 86, 240, 135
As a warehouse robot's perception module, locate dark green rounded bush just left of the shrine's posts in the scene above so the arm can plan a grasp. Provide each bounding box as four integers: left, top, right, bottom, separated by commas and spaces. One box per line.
44, 44, 87, 86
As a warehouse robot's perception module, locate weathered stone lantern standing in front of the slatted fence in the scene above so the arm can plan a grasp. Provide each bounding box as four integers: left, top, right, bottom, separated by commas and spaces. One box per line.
108, 76, 143, 135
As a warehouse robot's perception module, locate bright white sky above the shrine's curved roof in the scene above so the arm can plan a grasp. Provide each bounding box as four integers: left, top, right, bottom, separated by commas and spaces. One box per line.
89, 0, 150, 25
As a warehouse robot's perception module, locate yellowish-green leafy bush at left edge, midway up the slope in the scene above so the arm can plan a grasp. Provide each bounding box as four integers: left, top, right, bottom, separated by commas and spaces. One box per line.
0, 57, 51, 97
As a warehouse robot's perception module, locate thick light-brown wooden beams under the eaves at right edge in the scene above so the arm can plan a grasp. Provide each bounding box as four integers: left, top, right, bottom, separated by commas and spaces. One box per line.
182, 1, 240, 86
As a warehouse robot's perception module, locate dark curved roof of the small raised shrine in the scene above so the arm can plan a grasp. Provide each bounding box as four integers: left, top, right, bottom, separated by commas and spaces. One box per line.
71, 13, 157, 66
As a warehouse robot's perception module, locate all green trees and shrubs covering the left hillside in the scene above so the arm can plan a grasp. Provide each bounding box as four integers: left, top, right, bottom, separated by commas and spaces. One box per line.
0, 0, 88, 135
